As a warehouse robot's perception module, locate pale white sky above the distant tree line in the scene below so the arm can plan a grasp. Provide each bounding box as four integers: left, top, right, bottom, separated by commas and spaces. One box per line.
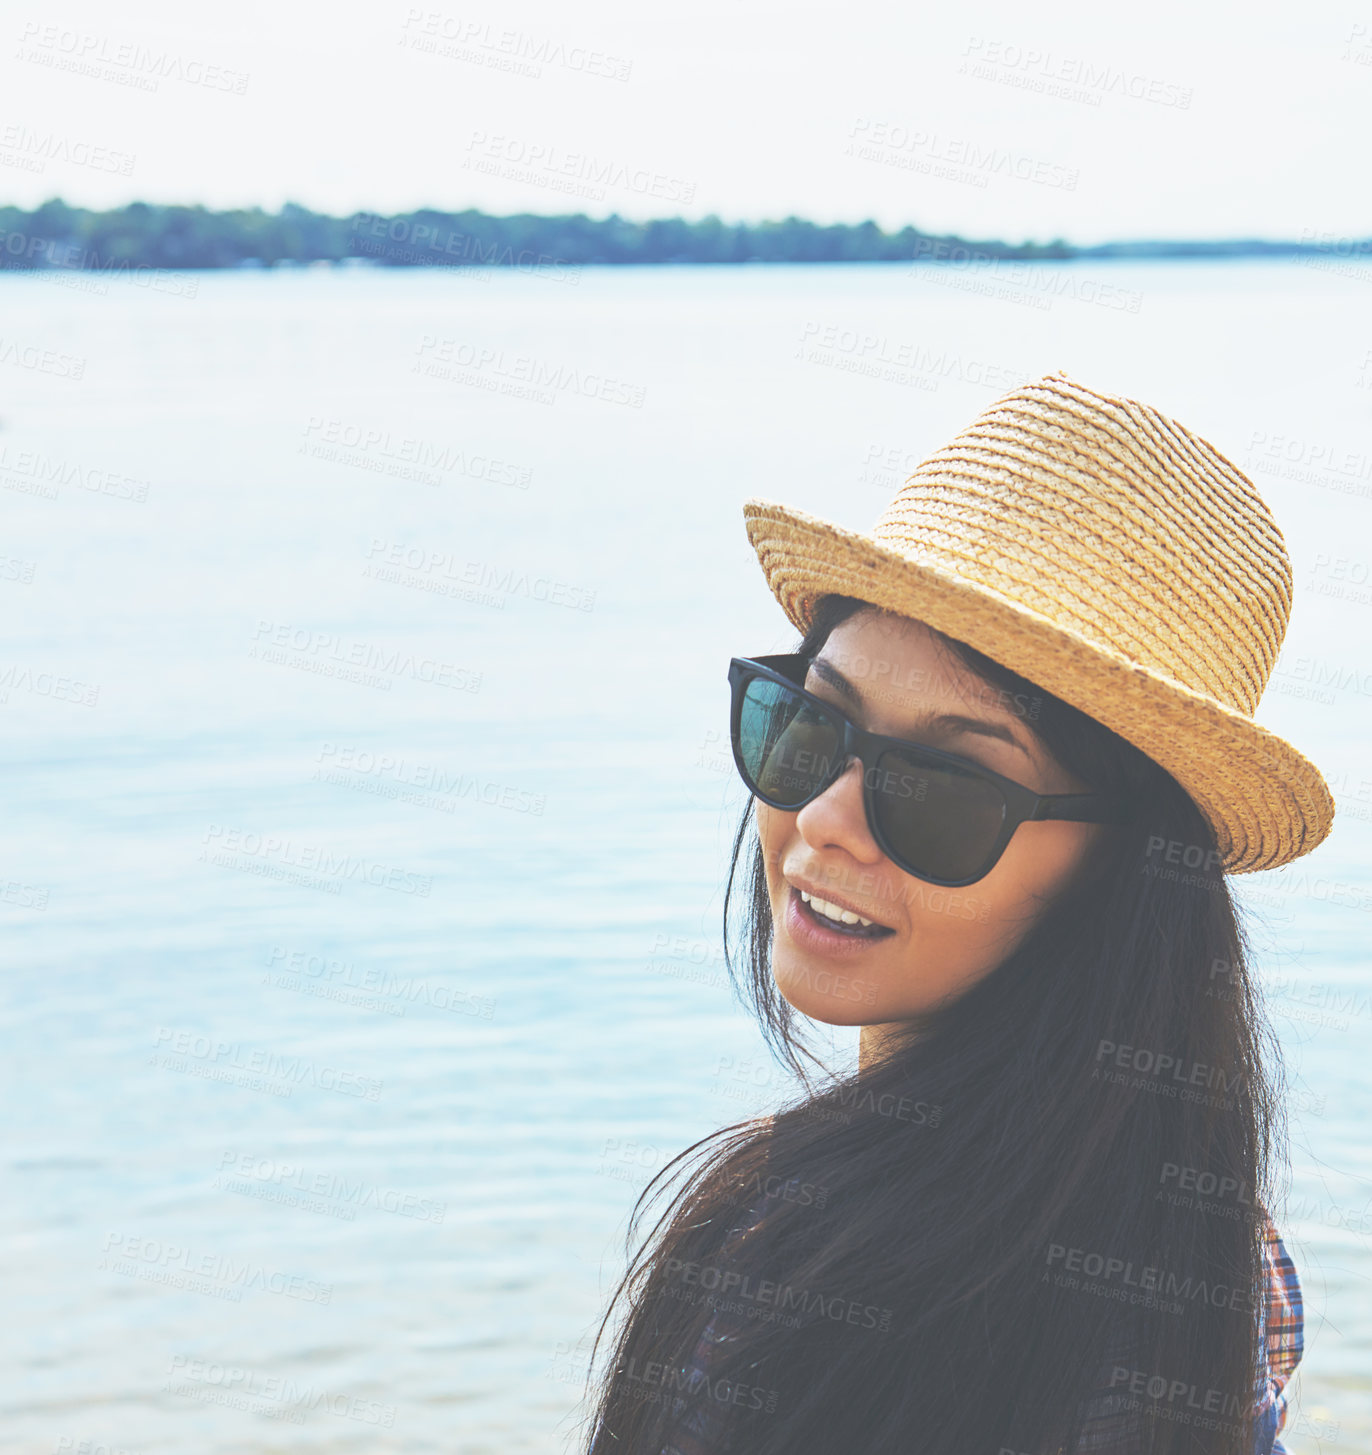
0, 0, 1372, 243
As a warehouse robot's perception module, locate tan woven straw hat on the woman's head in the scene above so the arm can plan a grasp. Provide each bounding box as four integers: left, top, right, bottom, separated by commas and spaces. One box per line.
743, 372, 1334, 874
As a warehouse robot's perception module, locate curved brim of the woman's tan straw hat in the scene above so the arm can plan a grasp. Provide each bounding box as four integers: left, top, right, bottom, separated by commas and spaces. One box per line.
743, 498, 1334, 874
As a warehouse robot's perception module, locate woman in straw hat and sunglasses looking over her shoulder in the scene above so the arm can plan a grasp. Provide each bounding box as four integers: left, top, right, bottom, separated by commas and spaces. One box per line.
586, 374, 1333, 1455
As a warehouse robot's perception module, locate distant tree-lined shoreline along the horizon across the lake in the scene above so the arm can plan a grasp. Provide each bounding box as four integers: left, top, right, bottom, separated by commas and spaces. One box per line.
0, 198, 1372, 275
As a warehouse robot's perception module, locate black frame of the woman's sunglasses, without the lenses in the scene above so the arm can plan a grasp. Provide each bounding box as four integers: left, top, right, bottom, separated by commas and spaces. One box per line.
729, 652, 1132, 889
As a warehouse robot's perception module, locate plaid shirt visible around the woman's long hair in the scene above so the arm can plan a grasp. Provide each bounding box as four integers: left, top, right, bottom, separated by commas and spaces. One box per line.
662, 1192, 1305, 1455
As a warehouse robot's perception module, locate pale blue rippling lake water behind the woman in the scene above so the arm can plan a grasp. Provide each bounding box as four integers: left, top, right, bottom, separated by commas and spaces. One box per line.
0, 260, 1372, 1455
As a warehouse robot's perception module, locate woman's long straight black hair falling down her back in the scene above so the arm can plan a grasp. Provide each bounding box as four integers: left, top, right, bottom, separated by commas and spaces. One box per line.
583, 597, 1285, 1455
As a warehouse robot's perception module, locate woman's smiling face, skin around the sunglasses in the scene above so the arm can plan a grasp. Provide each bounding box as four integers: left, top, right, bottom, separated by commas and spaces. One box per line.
755, 611, 1101, 1056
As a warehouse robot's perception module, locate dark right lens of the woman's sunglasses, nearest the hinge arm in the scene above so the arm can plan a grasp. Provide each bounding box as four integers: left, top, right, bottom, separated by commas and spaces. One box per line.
870, 751, 1005, 880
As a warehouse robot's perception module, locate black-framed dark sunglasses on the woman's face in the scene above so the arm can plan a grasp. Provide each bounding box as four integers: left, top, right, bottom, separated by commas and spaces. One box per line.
729, 652, 1130, 888
